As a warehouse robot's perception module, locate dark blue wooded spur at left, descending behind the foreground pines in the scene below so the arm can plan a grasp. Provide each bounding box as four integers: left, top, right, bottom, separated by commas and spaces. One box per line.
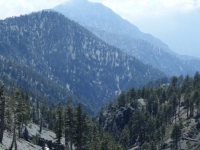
0, 55, 78, 105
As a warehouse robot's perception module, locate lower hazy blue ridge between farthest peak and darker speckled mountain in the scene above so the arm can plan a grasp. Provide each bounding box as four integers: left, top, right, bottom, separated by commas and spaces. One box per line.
91, 29, 200, 76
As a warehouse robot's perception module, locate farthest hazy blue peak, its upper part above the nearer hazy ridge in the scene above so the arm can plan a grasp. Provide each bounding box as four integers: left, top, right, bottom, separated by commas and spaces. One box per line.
53, 0, 167, 48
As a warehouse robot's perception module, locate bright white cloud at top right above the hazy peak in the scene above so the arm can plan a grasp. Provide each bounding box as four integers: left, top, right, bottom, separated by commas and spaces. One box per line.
89, 0, 200, 20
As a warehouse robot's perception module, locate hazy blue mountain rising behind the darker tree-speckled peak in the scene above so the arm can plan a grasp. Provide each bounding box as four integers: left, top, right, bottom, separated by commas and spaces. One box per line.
53, 0, 200, 76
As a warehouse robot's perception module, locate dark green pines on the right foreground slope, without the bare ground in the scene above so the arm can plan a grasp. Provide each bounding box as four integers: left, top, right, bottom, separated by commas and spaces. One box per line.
99, 72, 200, 149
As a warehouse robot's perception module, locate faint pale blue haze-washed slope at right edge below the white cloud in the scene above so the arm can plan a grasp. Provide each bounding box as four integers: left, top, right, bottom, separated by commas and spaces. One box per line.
136, 6, 200, 58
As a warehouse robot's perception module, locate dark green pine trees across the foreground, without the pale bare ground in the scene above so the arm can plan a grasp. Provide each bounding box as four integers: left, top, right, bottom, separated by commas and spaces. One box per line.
1, 61, 200, 150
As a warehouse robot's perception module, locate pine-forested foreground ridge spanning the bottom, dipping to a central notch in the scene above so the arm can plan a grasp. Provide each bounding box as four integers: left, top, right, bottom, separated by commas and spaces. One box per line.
0, 72, 200, 150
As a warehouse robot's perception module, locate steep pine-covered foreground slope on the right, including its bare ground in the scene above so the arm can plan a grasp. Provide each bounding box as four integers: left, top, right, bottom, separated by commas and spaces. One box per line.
97, 72, 200, 150
